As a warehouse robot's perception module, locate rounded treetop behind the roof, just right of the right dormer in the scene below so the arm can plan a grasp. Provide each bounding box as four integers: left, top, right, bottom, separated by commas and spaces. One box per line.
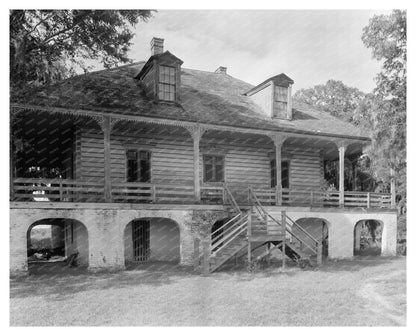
293, 79, 365, 122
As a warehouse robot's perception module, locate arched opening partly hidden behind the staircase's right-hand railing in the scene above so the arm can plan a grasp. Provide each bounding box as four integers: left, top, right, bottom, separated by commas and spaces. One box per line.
292, 218, 329, 258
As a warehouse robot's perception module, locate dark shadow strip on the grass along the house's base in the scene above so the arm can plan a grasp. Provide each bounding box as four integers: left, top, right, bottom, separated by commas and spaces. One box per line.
10, 256, 401, 300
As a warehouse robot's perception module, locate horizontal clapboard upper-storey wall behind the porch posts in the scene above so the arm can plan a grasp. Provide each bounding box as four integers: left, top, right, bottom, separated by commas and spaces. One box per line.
75, 125, 323, 190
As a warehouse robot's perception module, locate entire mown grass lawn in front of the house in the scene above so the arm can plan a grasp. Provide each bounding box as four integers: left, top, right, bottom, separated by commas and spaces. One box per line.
10, 257, 406, 326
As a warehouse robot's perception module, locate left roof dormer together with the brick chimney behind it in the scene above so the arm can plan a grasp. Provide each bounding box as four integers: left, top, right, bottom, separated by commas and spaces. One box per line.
135, 38, 183, 102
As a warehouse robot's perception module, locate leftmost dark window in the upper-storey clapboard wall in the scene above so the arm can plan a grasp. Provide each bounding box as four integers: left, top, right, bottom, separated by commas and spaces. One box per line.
126, 149, 151, 182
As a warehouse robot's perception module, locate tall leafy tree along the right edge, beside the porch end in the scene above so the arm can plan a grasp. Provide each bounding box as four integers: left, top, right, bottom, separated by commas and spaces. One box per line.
357, 10, 407, 207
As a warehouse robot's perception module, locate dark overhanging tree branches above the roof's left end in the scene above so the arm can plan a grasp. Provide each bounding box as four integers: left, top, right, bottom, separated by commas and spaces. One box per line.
10, 10, 152, 88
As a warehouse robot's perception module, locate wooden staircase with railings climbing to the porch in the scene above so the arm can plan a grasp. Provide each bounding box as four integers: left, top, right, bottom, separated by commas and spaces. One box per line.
196, 185, 322, 275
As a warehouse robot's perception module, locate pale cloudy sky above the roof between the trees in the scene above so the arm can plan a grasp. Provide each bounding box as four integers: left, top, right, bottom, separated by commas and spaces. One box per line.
125, 10, 388, 92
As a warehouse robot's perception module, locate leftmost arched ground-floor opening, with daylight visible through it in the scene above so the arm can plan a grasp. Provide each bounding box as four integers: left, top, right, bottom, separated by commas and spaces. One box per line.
27, 218, 89, 274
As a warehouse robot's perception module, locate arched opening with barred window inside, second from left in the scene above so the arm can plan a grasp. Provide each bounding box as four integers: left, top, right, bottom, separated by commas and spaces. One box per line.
124, 217, 181, 267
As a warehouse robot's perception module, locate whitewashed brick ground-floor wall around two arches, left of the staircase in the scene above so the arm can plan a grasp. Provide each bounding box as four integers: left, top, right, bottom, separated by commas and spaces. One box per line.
10, 208, 198, 274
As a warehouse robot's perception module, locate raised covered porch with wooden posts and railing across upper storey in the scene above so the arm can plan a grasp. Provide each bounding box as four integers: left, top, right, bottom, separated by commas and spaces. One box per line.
10, 106, 395, 208
